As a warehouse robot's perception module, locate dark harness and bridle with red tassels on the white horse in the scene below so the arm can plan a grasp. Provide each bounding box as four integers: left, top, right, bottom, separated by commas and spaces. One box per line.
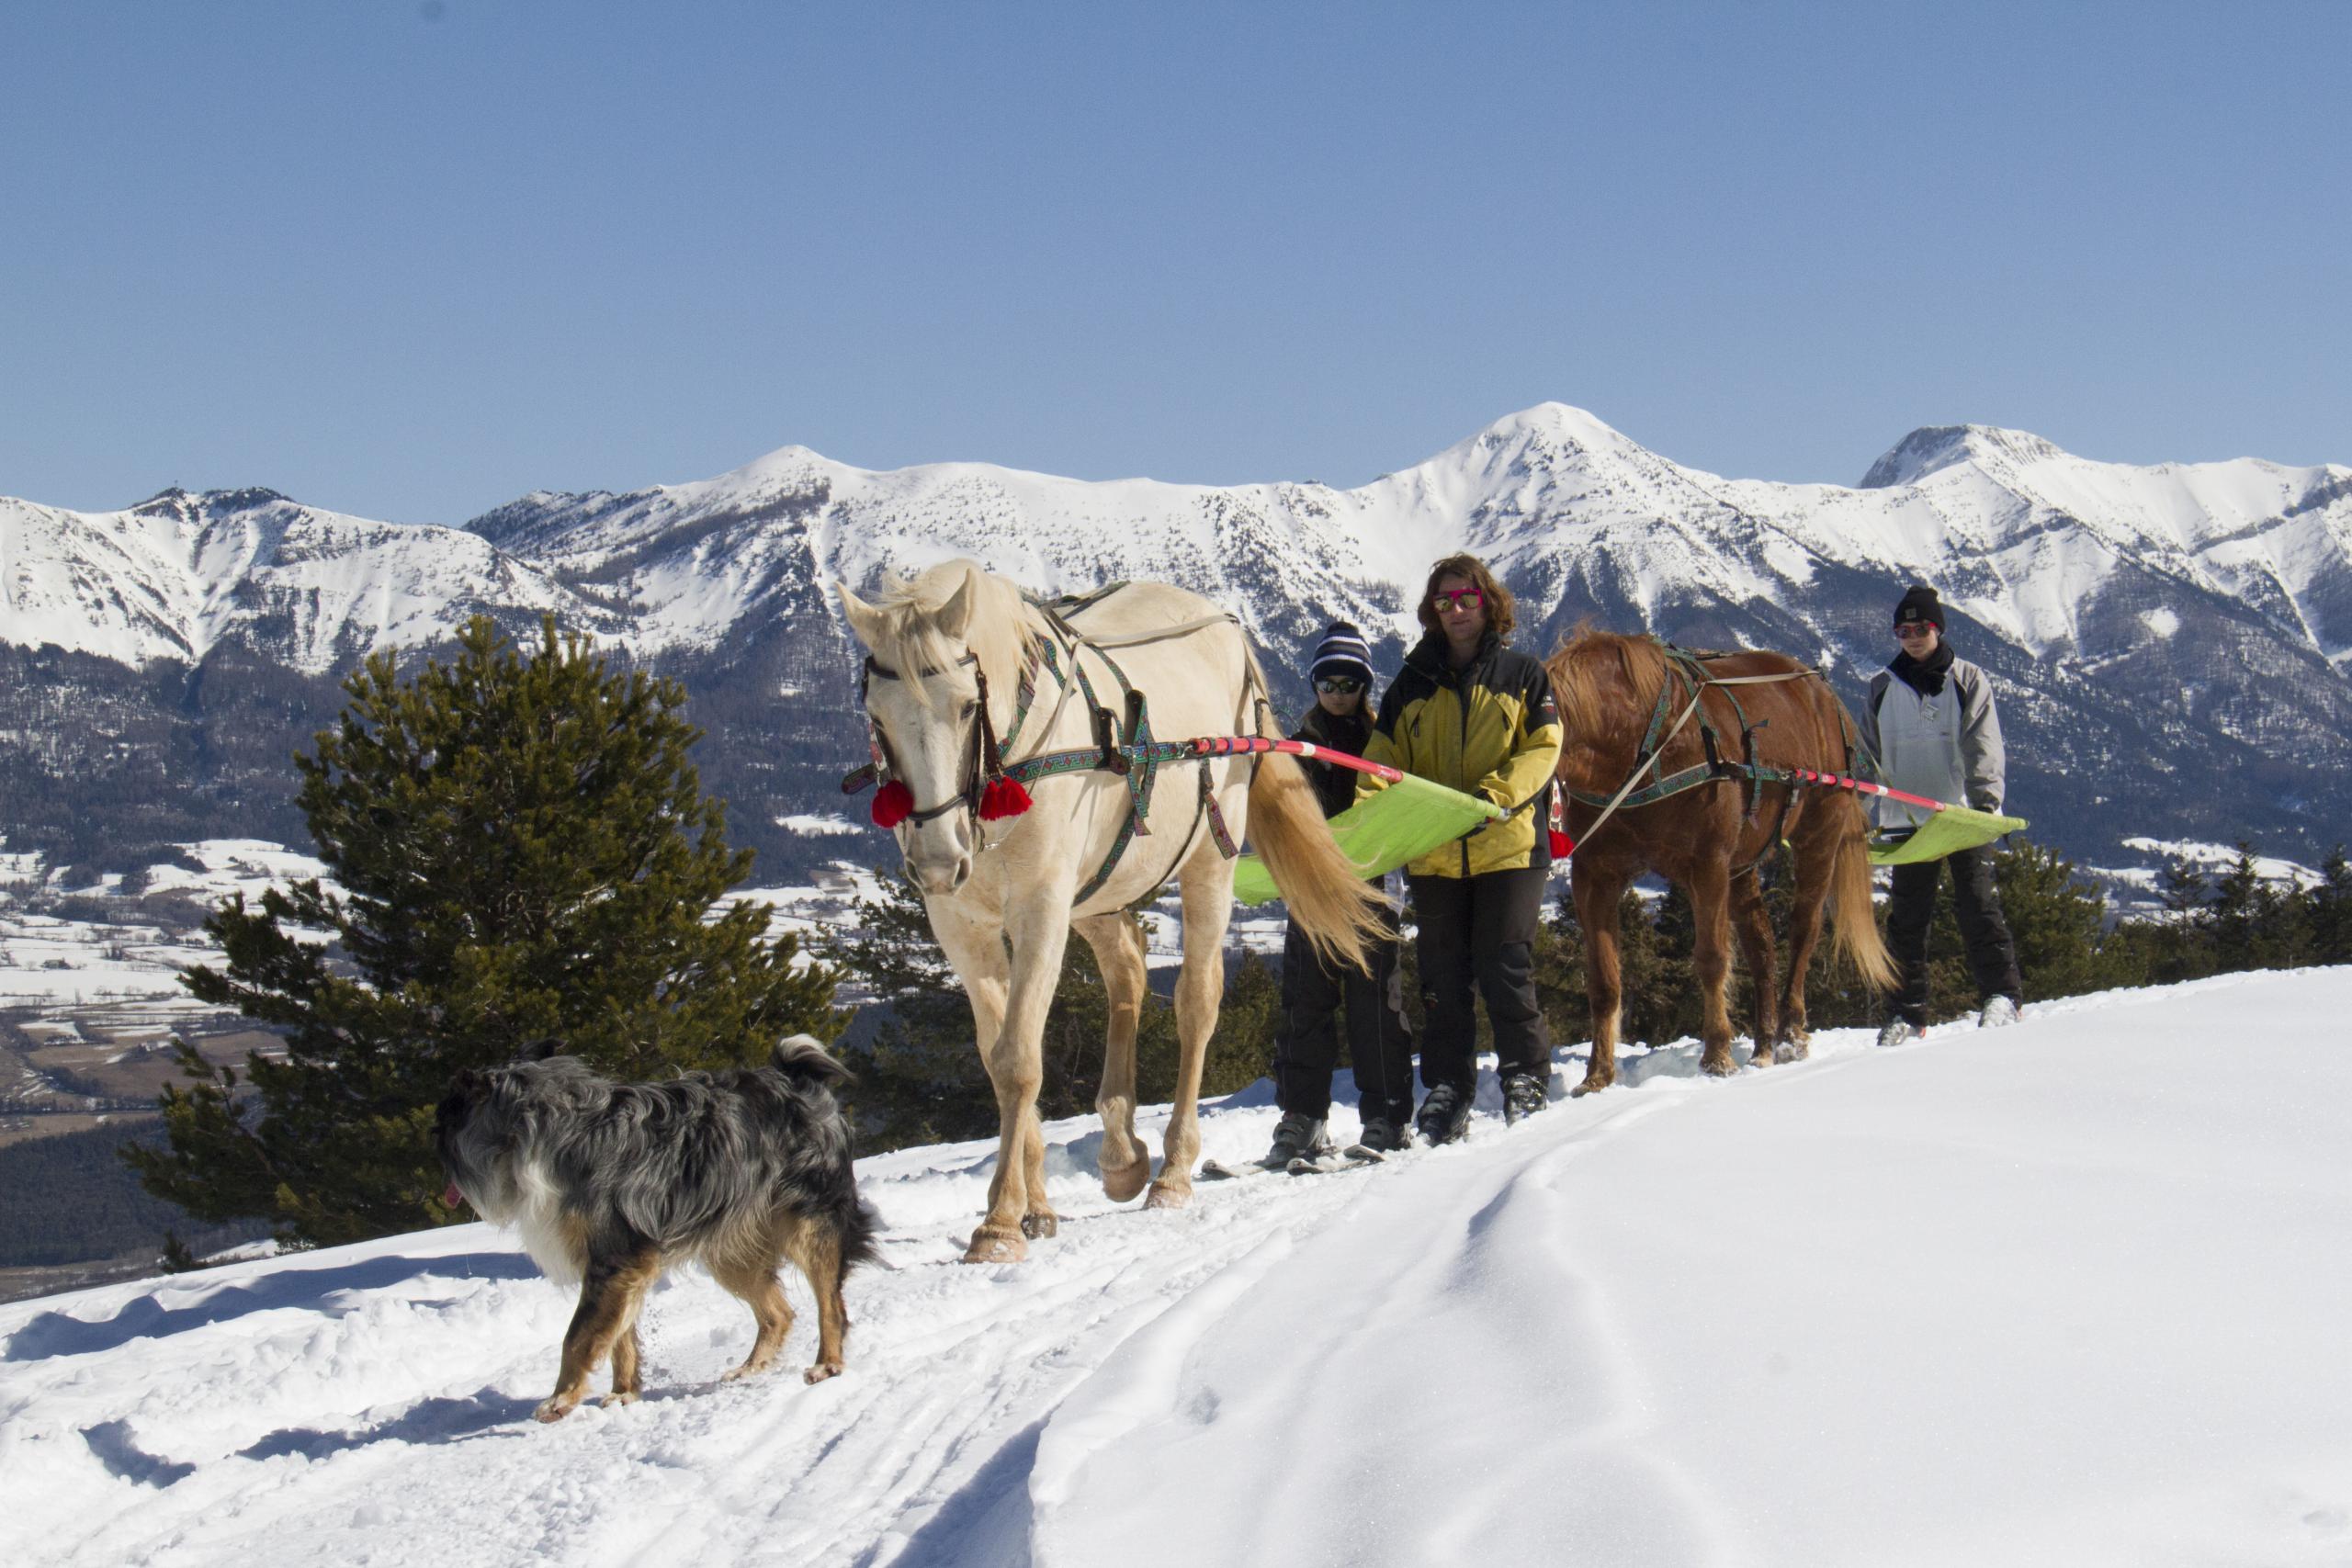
842, 583, 1265, 912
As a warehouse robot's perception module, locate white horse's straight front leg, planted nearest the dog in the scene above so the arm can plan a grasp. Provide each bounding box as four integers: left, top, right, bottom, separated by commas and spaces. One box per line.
950, 886, 1070, 1262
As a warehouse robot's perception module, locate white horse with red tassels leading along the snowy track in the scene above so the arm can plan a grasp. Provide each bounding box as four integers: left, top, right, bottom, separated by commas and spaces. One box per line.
840, 562, 1378, 1262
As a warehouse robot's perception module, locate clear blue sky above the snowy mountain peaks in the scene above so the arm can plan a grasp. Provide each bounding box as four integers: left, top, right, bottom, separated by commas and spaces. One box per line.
0, 0, 2352, 522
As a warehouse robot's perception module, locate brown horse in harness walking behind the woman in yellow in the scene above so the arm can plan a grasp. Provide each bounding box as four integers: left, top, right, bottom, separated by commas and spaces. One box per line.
1547, 627, 1895, 1093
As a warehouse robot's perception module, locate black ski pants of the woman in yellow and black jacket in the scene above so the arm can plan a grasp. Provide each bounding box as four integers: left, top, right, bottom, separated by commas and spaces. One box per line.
1414, 865, 1553, 1098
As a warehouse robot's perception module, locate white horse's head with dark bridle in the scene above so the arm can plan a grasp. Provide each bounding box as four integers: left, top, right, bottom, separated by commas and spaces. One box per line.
840, 569, 981, 894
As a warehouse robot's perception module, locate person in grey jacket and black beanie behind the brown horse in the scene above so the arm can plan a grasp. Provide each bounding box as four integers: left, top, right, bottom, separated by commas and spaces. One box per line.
1863, 583, 2023, 1046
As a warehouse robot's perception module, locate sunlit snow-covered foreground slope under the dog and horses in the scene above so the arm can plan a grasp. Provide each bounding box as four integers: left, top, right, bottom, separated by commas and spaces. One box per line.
0, 968, 2352, 1568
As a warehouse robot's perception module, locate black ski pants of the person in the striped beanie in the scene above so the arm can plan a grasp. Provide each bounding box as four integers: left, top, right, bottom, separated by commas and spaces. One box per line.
1275, 893, 1414, 1126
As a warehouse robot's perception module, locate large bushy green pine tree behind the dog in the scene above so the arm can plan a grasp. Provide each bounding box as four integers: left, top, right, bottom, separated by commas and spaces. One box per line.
127, 618, 840, 1244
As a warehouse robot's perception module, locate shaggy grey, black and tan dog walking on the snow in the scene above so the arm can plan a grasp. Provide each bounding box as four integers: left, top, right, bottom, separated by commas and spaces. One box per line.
433, 1034, 879, 1422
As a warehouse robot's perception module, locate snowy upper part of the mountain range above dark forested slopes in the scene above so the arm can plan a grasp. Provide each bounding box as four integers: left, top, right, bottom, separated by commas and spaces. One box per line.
0, 402, 2352, 670
